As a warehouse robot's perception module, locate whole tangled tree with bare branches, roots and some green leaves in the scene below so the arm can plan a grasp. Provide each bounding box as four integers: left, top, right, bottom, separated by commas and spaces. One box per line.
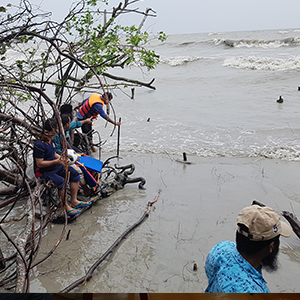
0, 0, 166, 292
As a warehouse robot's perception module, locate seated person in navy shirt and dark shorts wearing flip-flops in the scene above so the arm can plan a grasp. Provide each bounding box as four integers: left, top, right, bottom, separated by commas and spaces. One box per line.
33, 118, 91, 216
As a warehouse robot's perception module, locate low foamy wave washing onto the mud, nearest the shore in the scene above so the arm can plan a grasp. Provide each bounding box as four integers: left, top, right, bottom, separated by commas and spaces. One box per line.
105, 133, 300, 161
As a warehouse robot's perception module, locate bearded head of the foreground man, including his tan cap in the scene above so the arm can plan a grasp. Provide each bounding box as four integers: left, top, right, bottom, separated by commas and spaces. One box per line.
236, 205, 292, 271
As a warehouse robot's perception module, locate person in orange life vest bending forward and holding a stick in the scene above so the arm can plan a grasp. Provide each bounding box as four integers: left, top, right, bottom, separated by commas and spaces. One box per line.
76, 92, 121, 152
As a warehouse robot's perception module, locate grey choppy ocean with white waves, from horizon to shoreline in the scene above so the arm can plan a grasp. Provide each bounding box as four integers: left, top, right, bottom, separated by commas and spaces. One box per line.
95, 29, 300, 161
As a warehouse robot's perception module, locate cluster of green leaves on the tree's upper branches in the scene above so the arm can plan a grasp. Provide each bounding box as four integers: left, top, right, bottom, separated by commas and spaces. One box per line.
66, 5, 167, 73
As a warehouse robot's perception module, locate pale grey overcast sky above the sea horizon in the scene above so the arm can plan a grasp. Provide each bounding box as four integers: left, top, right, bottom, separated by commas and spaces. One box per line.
7, 0, 300, 34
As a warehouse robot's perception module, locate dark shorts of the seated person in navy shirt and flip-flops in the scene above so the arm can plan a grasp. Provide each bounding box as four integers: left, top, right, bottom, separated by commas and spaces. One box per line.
41, 165, 80, 190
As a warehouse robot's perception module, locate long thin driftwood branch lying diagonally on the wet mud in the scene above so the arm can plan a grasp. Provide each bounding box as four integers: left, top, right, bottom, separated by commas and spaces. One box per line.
60, 191, 160, 293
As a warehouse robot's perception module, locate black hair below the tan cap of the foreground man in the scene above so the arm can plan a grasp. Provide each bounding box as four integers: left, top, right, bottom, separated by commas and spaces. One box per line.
236, 224, 280, 255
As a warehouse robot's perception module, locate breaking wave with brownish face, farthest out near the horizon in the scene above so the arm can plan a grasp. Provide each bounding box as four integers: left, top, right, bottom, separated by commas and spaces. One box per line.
214, 37, 300, 48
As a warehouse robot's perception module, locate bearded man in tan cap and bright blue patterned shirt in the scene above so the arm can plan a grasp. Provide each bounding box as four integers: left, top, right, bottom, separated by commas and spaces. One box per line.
205, 205, 292, 293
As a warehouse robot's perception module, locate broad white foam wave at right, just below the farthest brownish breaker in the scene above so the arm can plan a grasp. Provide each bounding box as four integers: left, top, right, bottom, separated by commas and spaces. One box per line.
223, 56, 300, 71
